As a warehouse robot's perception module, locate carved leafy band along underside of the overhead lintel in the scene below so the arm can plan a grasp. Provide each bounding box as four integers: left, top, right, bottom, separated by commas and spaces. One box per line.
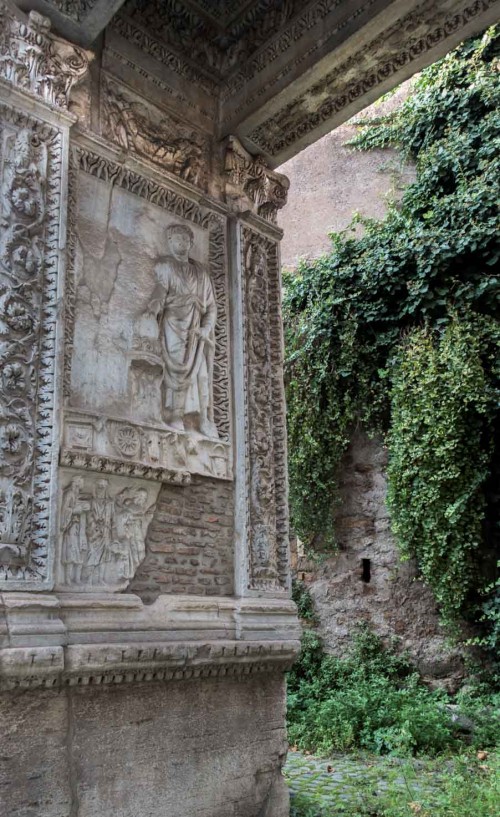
248, 0, 497, 156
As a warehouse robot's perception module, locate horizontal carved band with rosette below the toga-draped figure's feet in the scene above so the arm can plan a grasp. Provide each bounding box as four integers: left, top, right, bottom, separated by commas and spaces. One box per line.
61, 410, 232, 485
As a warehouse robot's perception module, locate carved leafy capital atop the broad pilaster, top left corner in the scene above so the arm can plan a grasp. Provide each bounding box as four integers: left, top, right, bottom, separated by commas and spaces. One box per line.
0, 0, 89, 108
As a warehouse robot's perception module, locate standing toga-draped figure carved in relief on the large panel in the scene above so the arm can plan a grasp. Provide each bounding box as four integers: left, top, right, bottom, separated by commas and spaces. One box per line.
149, 224, 218, 438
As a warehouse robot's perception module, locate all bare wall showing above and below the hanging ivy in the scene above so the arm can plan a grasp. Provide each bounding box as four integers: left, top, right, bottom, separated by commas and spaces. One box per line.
280, 89, 463, 686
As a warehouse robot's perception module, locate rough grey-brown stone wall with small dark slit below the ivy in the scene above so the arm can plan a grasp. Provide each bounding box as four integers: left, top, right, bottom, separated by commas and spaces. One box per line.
299, 431, 463, 686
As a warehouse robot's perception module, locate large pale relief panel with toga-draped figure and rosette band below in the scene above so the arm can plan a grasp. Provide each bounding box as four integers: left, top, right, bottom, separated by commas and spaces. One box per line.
61, 167, 231, 482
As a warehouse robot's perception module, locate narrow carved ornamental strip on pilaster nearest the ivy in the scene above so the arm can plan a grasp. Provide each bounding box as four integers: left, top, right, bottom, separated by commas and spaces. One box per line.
241, 227, 289, 590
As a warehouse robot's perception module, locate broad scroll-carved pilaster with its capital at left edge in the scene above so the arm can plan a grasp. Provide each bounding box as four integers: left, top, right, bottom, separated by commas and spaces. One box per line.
0, 2, 88, 590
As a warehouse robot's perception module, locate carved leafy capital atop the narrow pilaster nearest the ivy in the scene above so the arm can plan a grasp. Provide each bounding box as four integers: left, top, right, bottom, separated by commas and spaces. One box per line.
224, 136, 290, 224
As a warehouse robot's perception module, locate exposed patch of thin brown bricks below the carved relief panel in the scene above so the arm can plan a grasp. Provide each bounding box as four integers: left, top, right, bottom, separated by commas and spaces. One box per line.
129, 477, 234, 602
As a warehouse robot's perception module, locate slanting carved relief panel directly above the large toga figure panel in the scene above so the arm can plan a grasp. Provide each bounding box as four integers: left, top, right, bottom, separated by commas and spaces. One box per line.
101, 76, 210, 189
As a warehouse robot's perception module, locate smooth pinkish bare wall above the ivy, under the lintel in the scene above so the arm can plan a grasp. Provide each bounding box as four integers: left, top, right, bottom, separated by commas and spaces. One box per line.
278, 82, 413, 268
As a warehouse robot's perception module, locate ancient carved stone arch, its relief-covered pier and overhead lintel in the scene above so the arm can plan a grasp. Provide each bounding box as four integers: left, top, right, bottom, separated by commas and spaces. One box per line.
0, 0, 498, 817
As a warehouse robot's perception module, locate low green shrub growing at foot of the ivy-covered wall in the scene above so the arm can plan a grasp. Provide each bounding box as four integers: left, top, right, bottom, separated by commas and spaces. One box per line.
288, 627, 455, 755
